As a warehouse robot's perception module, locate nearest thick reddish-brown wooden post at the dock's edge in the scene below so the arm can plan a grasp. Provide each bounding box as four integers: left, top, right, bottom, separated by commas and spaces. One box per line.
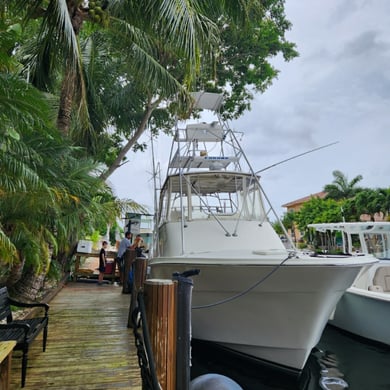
144, 279, 177, 390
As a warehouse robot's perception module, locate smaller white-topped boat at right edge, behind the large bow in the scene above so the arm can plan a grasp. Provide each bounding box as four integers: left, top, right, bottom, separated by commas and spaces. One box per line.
309, 222, 390, 345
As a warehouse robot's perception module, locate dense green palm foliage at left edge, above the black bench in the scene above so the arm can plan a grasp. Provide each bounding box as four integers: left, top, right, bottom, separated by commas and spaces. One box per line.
0, 58, 119, 299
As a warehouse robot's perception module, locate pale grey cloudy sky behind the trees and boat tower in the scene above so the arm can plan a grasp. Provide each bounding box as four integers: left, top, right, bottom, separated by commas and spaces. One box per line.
109, 0, 390, 216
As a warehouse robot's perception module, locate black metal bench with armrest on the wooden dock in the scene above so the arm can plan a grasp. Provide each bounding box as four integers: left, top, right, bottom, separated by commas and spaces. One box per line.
0, 287, 49, 387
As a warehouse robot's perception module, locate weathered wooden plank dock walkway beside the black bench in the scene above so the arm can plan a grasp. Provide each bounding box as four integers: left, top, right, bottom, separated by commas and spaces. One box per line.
10, 282, 142, 390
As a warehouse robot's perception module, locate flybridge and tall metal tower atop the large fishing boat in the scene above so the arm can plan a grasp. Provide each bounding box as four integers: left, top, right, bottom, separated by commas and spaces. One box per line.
158, 94, 267, 238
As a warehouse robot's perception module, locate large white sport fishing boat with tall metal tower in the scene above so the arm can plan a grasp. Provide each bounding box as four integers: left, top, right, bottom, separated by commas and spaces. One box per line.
149, 93, 375, 371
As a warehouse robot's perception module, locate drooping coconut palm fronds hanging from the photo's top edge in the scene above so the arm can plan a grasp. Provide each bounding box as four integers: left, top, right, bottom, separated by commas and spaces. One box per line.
9, 0, 221, 136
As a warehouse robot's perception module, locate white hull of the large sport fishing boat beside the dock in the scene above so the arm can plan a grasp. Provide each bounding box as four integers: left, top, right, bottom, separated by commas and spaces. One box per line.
150, 258, 362, 371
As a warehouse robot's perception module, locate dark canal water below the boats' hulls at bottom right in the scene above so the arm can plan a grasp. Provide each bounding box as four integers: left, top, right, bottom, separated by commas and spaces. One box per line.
191, 324, 390, 390
